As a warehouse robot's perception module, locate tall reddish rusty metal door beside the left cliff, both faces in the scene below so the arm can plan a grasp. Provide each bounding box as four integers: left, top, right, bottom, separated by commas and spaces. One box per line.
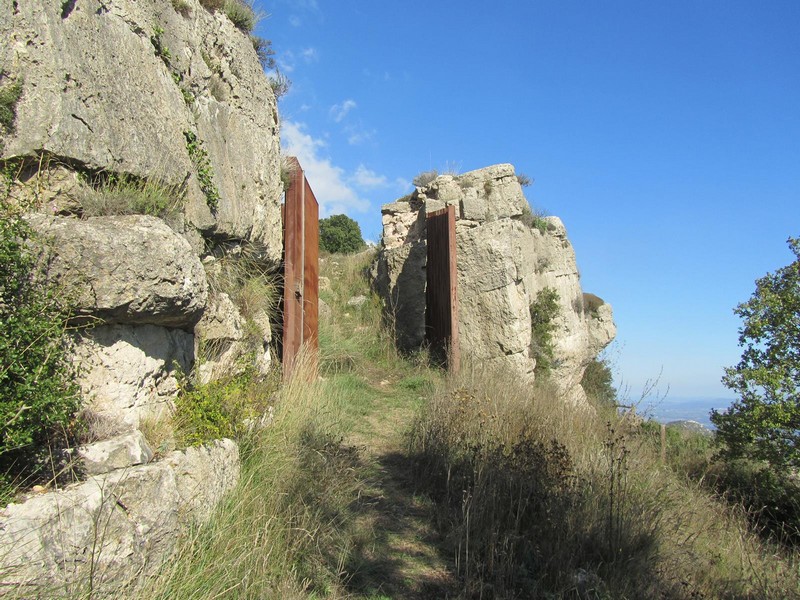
283, 157, 319, 376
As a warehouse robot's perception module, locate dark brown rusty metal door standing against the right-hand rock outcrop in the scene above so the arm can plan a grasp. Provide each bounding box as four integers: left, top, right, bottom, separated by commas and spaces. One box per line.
425, 206, 461, 372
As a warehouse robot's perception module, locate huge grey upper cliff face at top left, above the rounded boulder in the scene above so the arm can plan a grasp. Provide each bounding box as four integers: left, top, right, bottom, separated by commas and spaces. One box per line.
0, 0, 281, 262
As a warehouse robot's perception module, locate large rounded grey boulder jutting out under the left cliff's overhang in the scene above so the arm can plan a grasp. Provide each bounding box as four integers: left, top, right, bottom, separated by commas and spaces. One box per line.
29, 215, 208, 329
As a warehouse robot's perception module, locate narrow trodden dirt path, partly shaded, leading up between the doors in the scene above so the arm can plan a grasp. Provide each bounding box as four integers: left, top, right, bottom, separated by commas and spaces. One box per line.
346, 390, 458, 600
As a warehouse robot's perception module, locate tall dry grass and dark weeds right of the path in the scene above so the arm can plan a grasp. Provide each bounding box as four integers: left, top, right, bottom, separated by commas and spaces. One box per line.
413, 360, 800, 599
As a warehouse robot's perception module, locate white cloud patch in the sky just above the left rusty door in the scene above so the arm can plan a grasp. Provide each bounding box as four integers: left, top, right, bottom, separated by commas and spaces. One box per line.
281, 121, 370, 217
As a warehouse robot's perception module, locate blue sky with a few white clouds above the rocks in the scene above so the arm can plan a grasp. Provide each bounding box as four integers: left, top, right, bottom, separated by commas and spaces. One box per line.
256, 0, 800, 401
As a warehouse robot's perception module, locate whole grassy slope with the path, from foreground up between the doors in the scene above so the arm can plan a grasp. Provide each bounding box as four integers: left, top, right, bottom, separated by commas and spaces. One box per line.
137, 252, 800, 600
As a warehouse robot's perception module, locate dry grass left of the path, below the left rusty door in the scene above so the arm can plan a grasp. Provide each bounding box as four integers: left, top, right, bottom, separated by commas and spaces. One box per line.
131, 350, 358, 599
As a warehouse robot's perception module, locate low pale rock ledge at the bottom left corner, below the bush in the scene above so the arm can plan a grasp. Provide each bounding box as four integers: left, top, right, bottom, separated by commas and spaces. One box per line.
0, 440, 239, 598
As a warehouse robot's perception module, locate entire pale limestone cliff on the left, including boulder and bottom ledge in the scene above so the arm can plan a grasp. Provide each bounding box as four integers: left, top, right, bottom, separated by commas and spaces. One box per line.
0, 0, 282, 597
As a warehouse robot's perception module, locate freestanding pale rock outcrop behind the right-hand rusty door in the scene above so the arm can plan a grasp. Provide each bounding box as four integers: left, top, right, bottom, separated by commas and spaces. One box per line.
374, 165, 615, 402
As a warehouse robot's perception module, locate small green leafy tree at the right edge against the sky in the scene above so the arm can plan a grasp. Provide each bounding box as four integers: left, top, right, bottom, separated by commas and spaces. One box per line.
711, 238, 800, 472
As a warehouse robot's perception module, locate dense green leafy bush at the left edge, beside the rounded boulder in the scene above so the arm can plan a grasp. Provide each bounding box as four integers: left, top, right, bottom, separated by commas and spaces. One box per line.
0, 198, 79, 494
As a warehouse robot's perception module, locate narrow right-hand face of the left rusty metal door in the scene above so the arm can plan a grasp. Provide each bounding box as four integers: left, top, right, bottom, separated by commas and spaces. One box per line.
303, 176, 319, 356
